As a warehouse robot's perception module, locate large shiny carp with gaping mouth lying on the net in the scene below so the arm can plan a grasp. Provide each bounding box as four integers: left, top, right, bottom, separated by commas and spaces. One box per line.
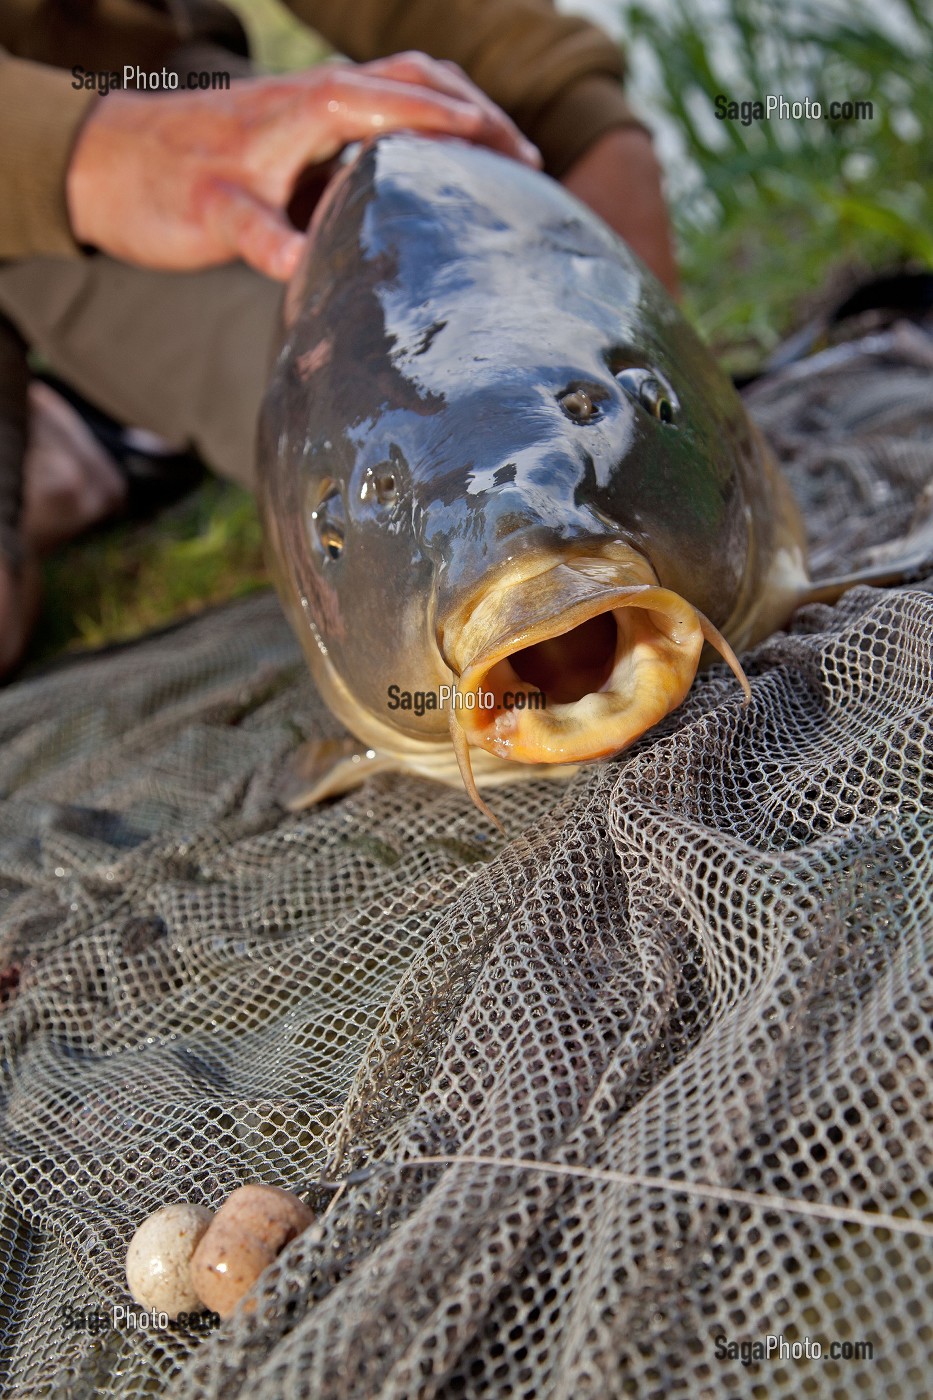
259, 134, 885, 820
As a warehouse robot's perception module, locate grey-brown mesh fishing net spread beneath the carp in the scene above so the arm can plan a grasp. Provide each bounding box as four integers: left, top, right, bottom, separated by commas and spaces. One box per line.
0, 326, 933, 1400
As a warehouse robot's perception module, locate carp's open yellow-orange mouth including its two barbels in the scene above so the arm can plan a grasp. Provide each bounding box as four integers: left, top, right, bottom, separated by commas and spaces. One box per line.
443, 546, 751, 811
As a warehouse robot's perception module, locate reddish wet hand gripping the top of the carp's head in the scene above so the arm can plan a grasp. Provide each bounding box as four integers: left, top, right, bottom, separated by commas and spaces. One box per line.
66, 53, 539, 281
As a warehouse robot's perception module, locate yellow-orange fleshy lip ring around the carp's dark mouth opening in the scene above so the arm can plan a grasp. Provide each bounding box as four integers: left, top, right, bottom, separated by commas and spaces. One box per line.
455, 584, 705, 763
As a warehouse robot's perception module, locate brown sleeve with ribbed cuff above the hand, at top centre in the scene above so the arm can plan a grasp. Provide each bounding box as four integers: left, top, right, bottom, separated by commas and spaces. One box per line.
287, 0, 642, 176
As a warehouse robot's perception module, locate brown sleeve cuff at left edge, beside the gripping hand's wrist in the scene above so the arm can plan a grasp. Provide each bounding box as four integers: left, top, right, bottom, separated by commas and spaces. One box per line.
0, 49, 99, 259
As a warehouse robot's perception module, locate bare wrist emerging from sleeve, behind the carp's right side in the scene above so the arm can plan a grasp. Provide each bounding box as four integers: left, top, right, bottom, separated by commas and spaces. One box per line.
560, 126, 679, 297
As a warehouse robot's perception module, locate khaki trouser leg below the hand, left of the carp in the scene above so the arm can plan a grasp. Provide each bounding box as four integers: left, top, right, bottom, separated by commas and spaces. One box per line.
0, 256, 283, 489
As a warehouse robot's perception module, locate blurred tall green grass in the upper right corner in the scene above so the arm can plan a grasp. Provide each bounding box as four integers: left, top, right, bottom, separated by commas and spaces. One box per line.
626, 0, 933, 372
